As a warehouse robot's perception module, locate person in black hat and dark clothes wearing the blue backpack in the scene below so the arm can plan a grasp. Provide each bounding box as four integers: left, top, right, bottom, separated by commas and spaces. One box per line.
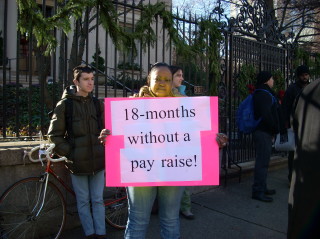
252, 71, 286, 202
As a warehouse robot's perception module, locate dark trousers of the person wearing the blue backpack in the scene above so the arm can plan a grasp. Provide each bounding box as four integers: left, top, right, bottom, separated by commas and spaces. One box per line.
252, 130, 272, 193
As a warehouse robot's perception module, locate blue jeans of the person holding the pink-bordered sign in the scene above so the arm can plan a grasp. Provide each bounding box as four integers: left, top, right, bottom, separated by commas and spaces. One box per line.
124, 186, 185, 239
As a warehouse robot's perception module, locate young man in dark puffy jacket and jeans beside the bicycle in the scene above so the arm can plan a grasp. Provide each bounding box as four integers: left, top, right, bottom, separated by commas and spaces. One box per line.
48, 65, 109, 239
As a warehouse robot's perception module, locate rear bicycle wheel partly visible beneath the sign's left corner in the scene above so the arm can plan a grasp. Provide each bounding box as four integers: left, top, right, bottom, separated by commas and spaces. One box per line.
104, 188, 128, 229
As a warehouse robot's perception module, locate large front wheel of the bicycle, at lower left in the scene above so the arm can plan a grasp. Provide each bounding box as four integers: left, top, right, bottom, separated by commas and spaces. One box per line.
0, 177, 66, 239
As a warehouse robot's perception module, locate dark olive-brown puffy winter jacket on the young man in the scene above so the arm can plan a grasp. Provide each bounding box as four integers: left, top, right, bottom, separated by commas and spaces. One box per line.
48, 86, 104, 175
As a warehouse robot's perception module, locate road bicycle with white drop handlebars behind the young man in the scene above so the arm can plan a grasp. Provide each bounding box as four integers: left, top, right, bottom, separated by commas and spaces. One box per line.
0, 144, 128, 239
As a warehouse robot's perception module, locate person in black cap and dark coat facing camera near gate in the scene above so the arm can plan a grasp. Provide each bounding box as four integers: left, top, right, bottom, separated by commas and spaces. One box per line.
282, 65, 310, 185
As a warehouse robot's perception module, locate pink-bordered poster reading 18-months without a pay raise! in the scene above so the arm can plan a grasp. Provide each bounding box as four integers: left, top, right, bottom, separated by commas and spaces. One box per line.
105, 97, 219, 186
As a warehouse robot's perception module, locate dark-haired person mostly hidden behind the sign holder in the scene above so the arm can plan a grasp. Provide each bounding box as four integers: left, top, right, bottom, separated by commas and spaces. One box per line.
170, 65, 194, 220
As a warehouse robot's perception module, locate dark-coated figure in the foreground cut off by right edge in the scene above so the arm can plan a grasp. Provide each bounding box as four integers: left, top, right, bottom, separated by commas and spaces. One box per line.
287, 80, 320, 239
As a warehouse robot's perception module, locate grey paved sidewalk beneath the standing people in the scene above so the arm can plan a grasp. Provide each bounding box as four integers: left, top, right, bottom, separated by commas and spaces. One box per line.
61, 164, 289, 239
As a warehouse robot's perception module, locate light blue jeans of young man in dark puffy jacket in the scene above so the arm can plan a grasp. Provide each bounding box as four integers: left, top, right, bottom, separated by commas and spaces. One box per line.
71, 170, 106, 236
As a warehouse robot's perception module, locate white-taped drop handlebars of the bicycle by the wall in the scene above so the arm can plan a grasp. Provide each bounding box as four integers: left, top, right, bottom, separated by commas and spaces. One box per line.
23, 144, 72, 163
